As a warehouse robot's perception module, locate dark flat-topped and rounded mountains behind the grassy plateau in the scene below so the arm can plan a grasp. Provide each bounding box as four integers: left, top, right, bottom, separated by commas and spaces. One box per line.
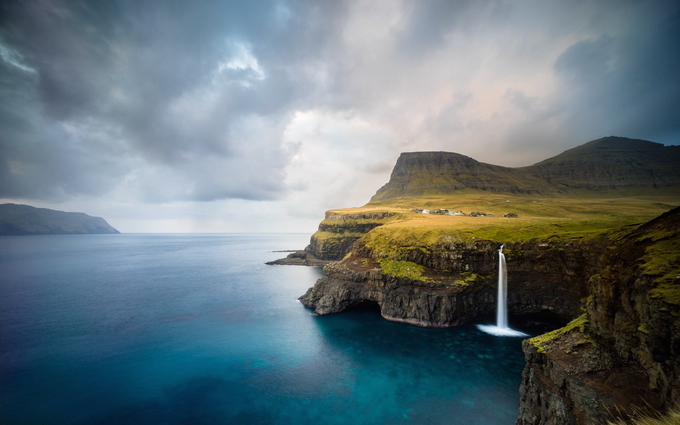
371, 137, 680, 201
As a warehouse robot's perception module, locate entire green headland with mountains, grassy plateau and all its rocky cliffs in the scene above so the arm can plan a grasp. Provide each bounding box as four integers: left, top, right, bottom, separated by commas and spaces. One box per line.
292, 137, 680, 425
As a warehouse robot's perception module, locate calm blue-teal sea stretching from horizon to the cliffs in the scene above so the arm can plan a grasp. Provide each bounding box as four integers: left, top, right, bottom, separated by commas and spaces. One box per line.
0, 234, 524, 425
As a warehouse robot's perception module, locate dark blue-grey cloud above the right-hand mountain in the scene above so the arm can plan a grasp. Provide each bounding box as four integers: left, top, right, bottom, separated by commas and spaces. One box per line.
555, 8, 680, 144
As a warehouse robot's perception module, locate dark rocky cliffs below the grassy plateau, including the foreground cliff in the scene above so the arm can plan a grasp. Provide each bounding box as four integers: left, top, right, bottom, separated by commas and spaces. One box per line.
300, 208, 680, 425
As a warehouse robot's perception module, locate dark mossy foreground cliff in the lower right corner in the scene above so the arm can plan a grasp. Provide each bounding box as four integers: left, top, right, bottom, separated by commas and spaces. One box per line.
517, 208, 680, 425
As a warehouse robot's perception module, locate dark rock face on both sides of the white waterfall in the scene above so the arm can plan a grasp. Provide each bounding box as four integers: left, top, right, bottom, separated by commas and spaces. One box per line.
301, 235, 596, 327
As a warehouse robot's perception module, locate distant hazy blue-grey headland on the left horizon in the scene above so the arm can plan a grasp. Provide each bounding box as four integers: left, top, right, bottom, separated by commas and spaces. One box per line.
0, 204, 120, 235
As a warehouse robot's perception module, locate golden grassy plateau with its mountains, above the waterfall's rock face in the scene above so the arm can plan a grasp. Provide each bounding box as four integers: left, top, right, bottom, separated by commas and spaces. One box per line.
268, 136, 680, 266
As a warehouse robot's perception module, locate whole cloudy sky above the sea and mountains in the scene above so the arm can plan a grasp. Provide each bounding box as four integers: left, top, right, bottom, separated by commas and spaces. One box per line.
0, 0, 680, 234
